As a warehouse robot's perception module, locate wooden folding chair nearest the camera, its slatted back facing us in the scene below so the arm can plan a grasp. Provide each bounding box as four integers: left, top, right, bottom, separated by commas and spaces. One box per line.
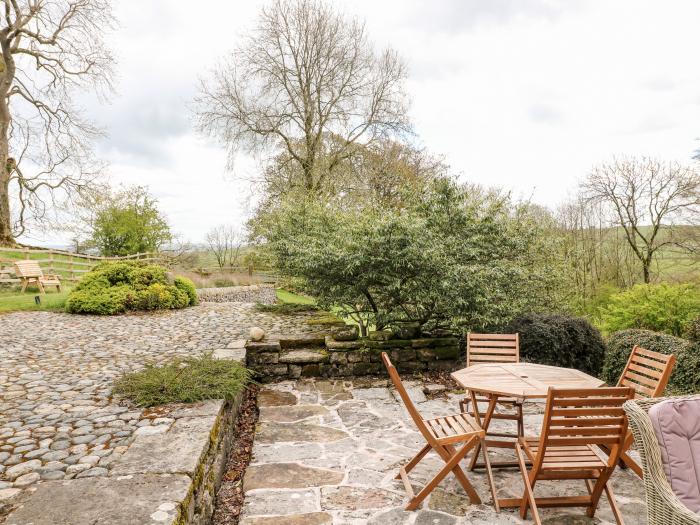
512, 387, 634, 525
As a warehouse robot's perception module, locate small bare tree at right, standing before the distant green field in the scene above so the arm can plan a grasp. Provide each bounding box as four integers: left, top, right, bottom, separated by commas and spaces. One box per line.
582, 158, 700, 283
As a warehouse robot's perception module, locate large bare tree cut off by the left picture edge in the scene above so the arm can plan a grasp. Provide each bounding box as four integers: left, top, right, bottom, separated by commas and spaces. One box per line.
0, 0, 113, 244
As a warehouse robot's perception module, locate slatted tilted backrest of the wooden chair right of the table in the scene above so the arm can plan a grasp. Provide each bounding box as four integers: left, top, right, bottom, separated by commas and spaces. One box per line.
617, 345, 676, 397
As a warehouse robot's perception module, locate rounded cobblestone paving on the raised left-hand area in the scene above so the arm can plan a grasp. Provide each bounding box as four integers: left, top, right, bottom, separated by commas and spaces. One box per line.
0, 303, 320, 496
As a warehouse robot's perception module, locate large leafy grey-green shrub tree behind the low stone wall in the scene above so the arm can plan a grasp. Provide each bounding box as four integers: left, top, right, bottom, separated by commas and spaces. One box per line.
264, 179, 559, 331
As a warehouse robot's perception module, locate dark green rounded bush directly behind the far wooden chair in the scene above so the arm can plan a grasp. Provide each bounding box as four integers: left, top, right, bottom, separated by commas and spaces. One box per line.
503, 313, 605, 375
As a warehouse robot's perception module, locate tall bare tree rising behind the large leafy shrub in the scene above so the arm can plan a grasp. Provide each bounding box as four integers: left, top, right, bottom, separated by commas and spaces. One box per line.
197, 0, 410, 193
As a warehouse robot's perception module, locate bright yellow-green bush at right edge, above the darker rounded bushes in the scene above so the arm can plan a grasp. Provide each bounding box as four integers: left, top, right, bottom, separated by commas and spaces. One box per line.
599, 284, 700, 336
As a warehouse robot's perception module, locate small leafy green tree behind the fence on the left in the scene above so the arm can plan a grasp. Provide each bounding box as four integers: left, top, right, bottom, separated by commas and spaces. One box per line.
91, 186, 172, 256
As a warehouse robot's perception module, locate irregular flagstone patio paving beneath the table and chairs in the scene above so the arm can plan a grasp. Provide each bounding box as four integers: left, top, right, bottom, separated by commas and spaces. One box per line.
241, 380, 646, 525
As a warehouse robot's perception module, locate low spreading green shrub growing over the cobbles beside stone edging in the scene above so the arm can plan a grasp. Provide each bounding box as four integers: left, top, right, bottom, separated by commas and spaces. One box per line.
113, 354, 250, 407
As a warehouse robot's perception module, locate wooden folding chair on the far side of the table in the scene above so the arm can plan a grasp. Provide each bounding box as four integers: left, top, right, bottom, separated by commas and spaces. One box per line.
459, 332, 524, 438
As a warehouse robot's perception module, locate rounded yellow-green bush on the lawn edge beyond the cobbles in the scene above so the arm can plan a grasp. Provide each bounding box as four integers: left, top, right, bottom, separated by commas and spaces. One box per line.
66, 262, 196, 315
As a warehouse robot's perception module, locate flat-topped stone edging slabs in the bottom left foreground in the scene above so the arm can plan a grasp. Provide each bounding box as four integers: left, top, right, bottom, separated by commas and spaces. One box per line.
5, 392, 243, 525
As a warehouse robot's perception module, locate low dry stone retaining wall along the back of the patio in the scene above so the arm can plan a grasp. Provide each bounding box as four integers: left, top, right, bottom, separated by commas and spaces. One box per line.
246, 336, 464, 382
